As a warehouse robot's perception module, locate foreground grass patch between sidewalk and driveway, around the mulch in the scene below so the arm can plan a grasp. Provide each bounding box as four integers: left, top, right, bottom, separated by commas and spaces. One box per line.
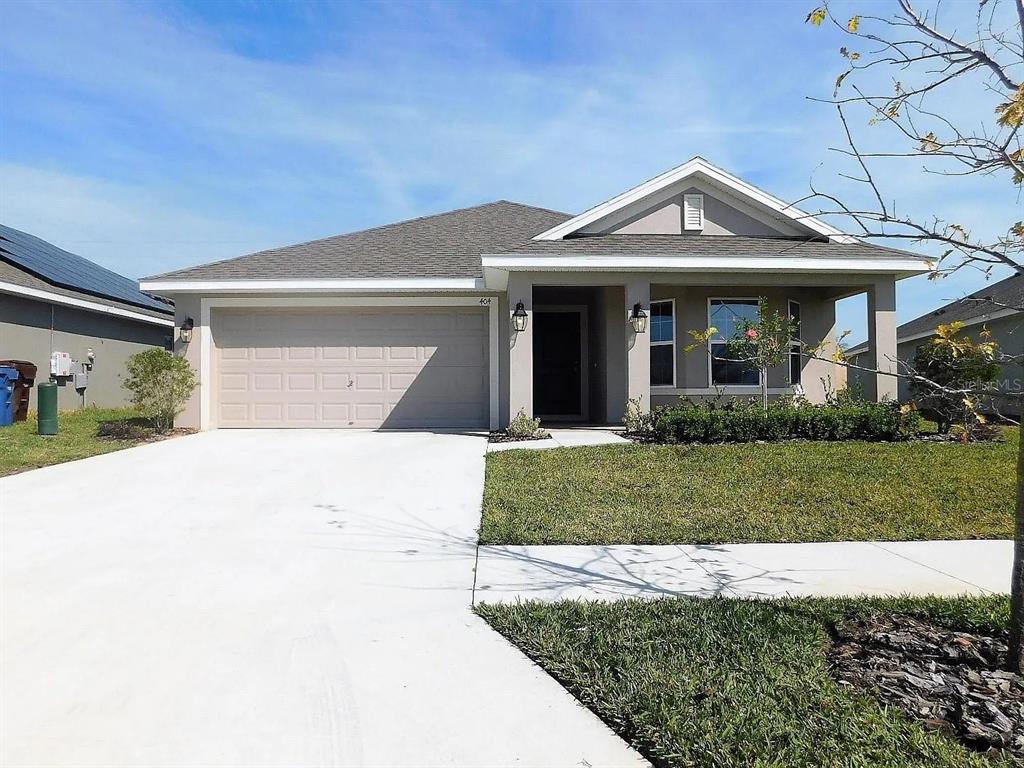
477, 596, 1010, 768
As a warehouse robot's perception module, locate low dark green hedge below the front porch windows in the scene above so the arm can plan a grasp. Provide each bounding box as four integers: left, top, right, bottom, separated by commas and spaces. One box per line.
632, 398, 921, 443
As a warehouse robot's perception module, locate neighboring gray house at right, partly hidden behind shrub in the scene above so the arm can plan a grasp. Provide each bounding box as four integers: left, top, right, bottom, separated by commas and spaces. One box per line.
847, 274, 1024, 415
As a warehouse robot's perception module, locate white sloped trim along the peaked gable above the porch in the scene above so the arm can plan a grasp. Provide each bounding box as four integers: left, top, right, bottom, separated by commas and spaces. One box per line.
534, 157, 857, 244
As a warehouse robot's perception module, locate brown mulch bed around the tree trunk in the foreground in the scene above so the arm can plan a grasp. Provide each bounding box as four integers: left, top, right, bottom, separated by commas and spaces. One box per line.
828, 613, 1024, 765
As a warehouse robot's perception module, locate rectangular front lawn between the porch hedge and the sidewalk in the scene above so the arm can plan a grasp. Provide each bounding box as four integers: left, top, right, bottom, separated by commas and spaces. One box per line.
480, 429, 1019, 544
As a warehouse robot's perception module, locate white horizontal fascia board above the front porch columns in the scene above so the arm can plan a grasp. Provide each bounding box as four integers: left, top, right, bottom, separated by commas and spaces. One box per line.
482, 254, 934, 276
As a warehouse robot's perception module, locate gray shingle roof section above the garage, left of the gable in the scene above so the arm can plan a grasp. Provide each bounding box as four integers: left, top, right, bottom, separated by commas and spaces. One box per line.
144, 200, 571, 280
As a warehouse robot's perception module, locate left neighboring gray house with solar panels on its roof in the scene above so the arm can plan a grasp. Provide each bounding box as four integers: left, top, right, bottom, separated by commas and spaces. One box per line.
0, 225, 174, 409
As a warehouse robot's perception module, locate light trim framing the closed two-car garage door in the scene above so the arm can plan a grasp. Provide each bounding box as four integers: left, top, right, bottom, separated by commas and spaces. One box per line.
199, 296, 500, 431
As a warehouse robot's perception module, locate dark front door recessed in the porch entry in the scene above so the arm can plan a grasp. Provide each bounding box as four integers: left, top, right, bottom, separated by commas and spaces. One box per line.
534, 310, 583, 418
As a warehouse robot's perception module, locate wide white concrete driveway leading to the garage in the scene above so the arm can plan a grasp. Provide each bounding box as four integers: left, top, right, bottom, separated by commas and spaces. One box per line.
0, 431, 642, 767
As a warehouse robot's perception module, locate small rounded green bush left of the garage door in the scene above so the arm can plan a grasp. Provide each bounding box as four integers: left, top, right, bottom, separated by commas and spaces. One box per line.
123, 347, 197, 432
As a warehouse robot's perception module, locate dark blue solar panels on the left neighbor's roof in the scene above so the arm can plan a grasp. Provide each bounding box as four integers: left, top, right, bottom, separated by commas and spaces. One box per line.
0, 224, 170, 311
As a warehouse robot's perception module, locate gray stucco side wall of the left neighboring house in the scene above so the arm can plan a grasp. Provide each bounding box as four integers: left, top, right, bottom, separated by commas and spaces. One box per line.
0, 294, 171, 410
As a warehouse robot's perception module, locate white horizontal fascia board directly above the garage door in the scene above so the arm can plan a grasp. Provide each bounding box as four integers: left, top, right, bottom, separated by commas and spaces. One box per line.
140, 278, 483, 293
